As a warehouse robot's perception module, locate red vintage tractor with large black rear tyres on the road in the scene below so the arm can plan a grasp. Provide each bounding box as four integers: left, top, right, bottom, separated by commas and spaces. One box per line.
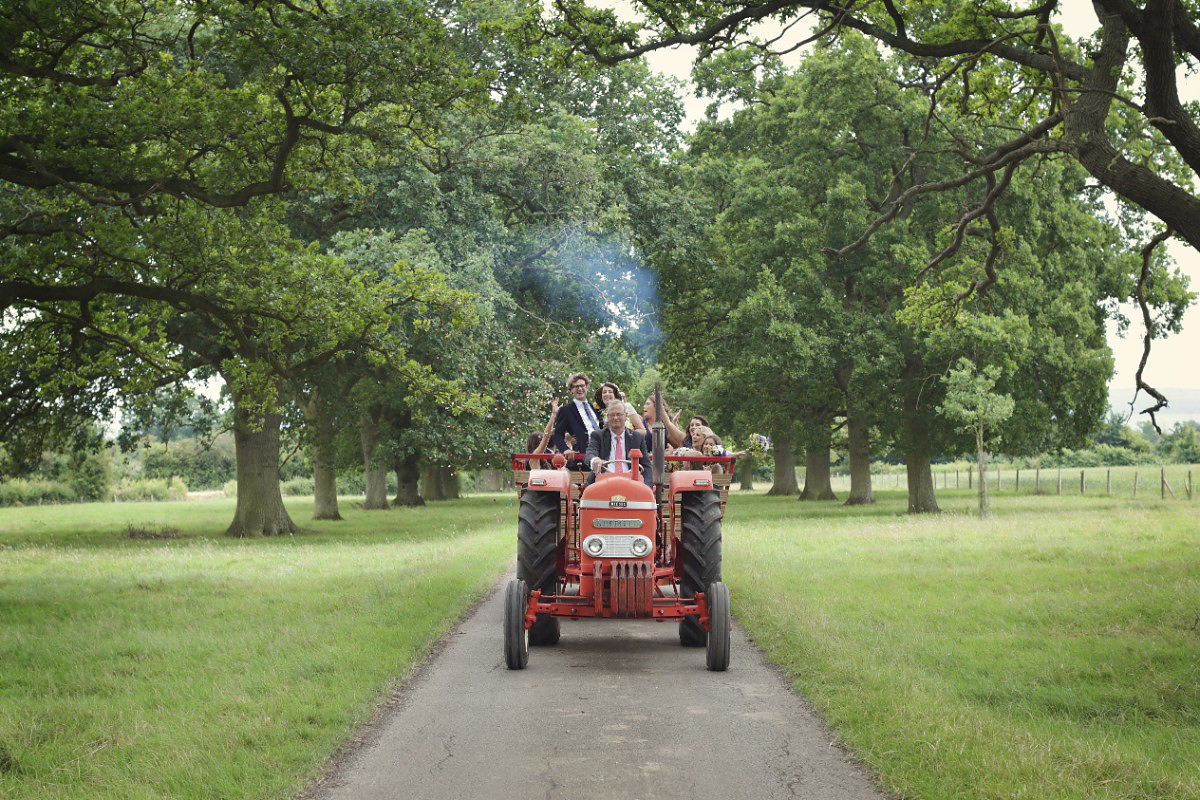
504, 392, 733, 672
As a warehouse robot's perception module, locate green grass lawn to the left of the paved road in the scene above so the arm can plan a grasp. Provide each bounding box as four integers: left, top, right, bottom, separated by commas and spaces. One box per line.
0, 498, 515, 800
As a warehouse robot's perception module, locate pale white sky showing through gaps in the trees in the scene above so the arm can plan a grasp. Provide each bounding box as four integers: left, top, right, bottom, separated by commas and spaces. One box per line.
609, 0, 1200, 400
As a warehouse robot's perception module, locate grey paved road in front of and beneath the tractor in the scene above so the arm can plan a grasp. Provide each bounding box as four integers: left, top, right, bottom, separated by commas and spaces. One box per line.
306, 578, 886, 800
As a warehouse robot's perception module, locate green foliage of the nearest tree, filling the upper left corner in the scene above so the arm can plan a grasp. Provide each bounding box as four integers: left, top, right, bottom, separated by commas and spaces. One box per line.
0, 0, 500, 474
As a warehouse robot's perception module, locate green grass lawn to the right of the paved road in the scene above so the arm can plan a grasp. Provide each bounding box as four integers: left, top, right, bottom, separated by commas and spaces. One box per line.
725, 489, 1200, 800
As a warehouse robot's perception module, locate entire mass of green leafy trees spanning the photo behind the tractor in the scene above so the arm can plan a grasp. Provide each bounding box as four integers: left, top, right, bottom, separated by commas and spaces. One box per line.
0, 0, 1200, 525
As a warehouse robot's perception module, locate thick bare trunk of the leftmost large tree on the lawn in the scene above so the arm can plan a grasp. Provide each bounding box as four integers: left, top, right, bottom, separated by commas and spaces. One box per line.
226, 392, 296, 536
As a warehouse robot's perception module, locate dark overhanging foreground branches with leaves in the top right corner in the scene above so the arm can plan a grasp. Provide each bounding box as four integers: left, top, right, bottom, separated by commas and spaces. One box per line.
554, 0, 1200, 249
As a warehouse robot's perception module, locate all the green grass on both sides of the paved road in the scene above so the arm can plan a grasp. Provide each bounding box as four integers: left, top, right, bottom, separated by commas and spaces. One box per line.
0, 489, 1200, 800
